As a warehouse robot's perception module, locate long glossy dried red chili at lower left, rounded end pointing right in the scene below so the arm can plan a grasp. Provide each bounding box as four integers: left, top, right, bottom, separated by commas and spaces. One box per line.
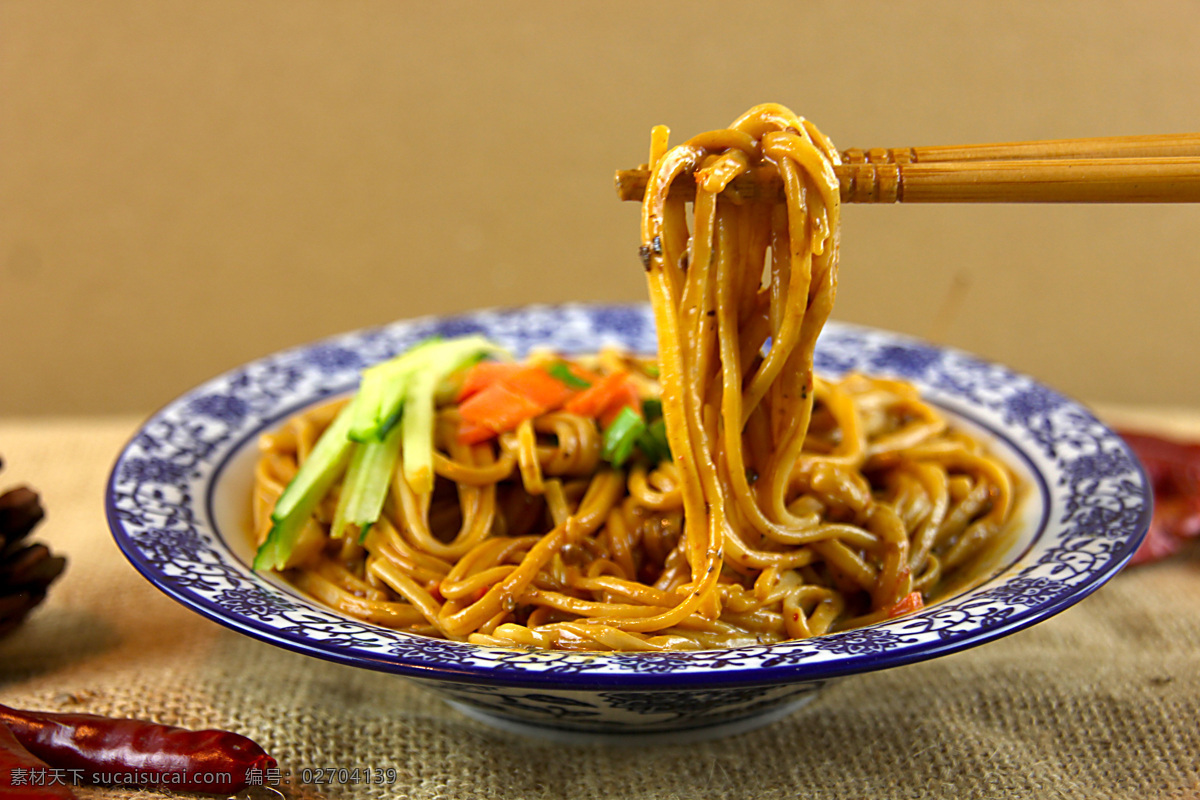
0, 705, 276, 793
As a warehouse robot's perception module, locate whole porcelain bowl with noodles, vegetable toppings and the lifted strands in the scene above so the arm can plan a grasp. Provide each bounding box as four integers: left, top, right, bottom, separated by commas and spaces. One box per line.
107, 104, 1150, 738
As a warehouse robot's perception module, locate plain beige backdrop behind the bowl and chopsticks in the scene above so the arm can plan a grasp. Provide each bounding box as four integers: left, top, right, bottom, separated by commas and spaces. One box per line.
0, 0, 1200, 416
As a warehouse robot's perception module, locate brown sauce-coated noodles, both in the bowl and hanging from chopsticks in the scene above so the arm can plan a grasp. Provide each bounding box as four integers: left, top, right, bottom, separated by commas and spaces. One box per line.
254, 106, 1014, 650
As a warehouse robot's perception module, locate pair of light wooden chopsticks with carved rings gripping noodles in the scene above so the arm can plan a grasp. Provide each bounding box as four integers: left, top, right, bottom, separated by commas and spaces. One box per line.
617, 133, 1200, 203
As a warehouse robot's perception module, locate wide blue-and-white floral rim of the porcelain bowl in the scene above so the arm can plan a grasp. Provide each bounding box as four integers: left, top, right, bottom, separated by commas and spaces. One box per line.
104, 303, 1151, 691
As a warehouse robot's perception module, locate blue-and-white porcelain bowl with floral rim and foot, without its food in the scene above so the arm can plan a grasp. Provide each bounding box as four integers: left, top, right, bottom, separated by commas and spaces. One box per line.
107, 305, 1151, 738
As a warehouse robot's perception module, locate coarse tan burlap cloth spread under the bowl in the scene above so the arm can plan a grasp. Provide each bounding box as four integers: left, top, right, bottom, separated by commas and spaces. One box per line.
0, 414, 1200, 799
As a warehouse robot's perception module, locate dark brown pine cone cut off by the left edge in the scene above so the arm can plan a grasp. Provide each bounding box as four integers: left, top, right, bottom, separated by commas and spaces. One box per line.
0, 455, 66, 636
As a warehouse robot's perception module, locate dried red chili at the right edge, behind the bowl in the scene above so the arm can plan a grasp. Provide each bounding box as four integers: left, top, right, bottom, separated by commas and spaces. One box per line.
1120, 431, 1200, 564
